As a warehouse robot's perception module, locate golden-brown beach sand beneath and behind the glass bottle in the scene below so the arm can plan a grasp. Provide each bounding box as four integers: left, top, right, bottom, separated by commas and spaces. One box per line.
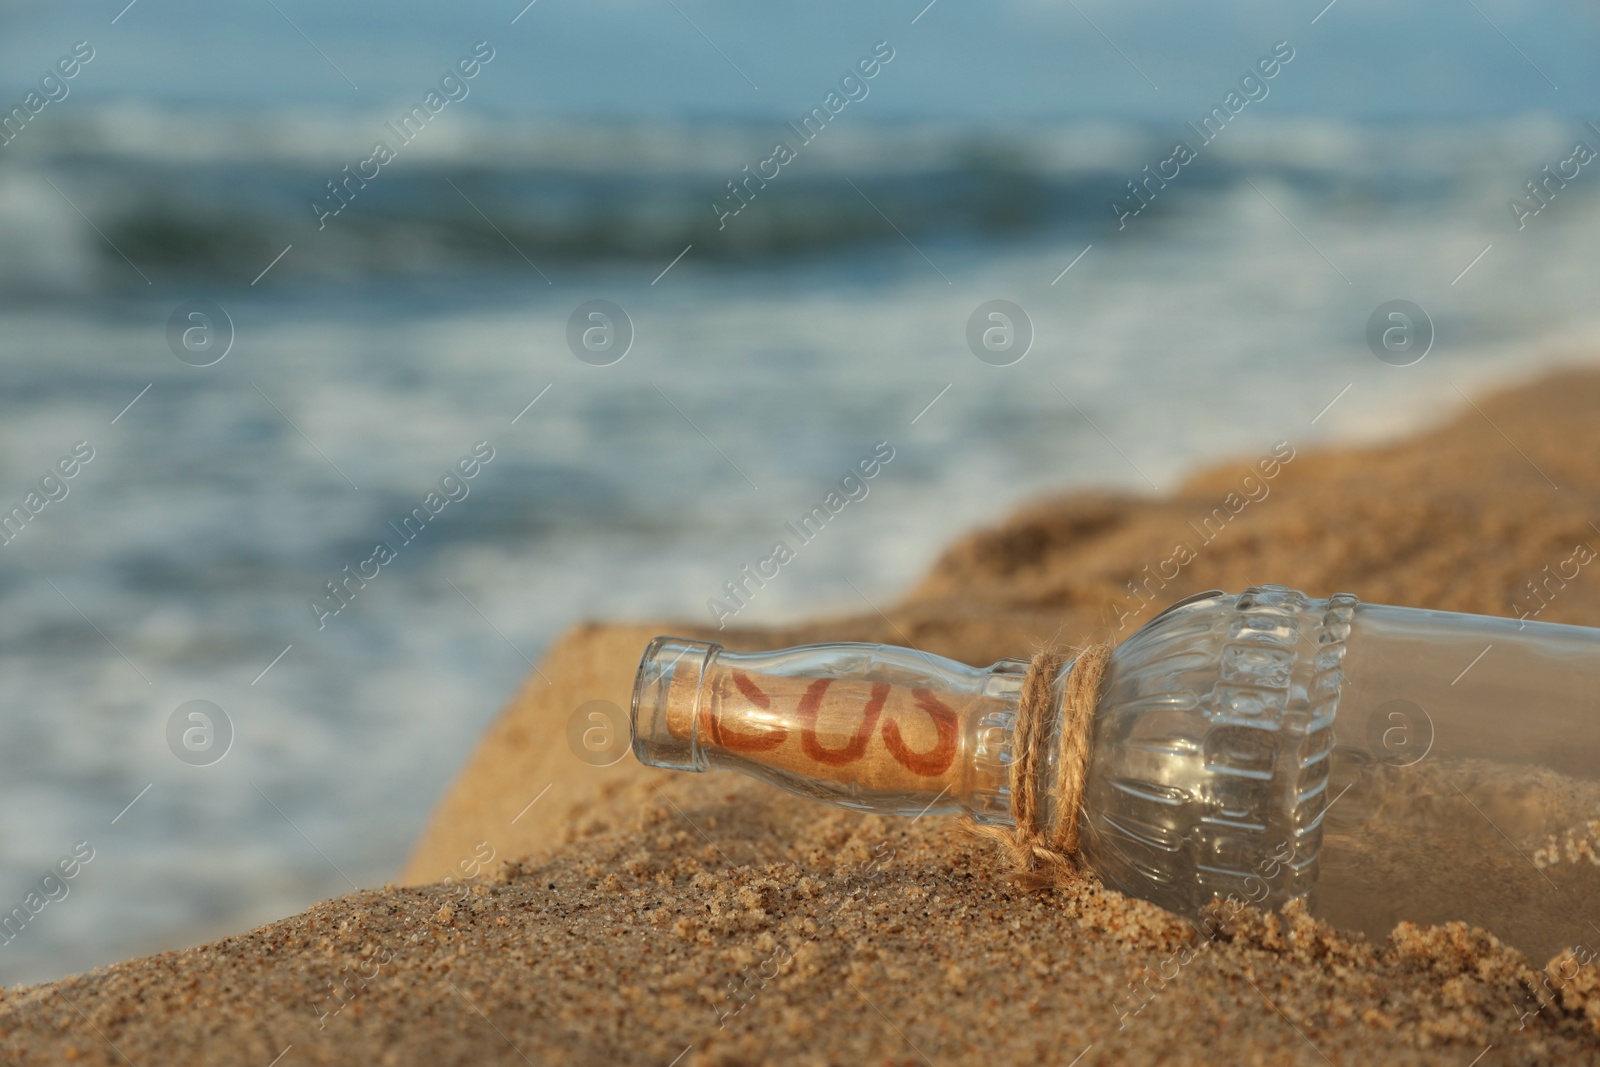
0, 373, 1600, 1067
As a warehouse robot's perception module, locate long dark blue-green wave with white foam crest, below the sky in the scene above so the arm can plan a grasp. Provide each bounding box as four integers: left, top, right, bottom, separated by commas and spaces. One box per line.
0, 104, 1565, 293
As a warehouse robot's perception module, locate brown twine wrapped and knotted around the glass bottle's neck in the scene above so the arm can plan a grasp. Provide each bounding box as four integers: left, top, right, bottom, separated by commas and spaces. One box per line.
973, 645, 1112, 888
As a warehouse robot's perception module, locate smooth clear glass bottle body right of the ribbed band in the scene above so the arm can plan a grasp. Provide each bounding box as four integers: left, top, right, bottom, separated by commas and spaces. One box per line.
1314, 605, 1600, 963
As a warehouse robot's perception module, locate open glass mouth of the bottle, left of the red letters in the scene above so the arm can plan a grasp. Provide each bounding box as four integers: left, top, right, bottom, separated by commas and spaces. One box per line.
630, 637, 722, 771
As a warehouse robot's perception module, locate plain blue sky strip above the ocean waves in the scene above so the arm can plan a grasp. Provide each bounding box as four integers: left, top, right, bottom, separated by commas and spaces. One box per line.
0, 0, 1600, 123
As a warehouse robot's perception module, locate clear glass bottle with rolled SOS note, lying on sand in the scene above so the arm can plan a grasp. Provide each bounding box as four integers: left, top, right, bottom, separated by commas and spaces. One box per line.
634, 585, 1600, 961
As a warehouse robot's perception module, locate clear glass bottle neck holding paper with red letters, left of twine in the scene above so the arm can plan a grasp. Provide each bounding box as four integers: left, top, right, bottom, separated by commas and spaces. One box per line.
634, 638, 1066, 825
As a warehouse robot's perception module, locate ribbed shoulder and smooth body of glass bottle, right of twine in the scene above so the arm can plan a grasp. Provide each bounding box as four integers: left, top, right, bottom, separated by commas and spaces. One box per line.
1083, 587, 1600, 961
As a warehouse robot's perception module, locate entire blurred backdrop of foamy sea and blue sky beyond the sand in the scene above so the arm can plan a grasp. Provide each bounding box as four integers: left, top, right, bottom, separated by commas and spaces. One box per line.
9, 0, 1600, 982
